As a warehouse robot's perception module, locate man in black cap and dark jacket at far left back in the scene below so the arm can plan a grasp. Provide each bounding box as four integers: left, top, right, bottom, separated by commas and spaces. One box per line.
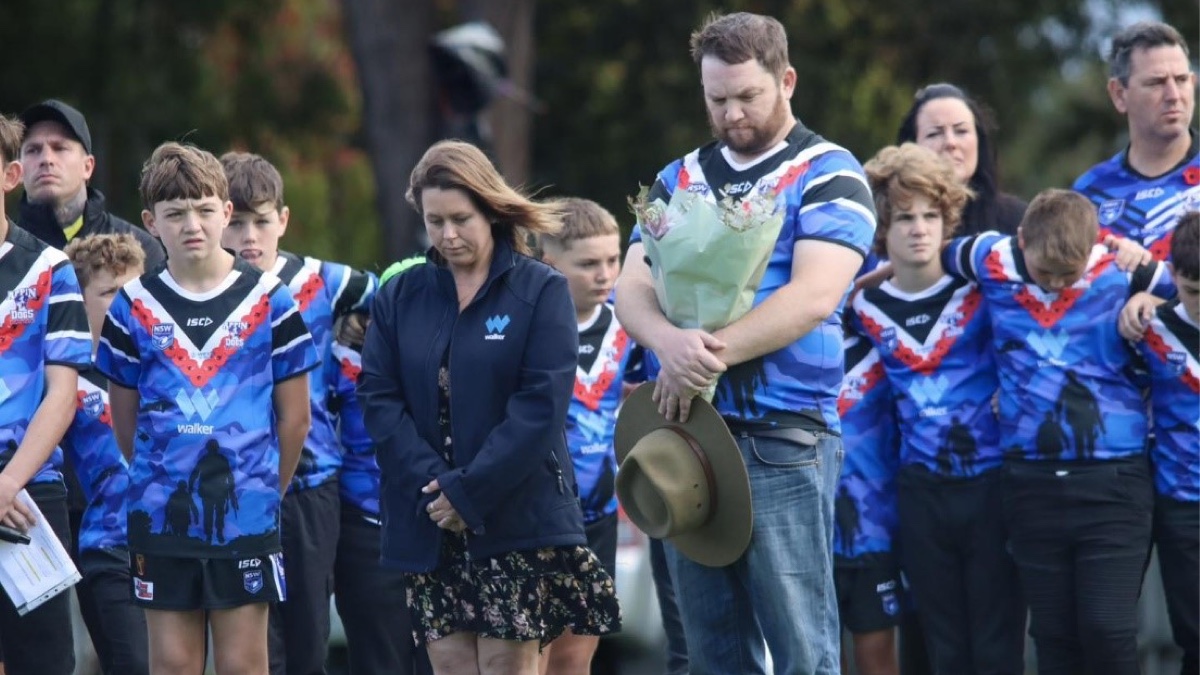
18, 98, 166, 265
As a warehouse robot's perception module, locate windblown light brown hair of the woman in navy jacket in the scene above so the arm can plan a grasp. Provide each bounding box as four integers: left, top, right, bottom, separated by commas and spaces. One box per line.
404, 141, 563, 256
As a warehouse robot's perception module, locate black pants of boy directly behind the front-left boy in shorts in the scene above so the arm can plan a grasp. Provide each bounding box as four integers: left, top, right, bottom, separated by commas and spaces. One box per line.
268, 480, 341, 675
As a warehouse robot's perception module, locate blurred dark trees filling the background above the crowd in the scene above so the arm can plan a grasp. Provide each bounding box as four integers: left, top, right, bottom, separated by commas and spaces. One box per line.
0, 0, 1200, 263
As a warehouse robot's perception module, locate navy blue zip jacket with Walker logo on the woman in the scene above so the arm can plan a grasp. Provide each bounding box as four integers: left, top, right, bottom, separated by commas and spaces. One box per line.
358, 240, 586, 572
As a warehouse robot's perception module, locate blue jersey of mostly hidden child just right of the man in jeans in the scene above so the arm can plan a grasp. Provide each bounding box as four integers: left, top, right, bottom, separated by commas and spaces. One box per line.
833, 335, 900, 566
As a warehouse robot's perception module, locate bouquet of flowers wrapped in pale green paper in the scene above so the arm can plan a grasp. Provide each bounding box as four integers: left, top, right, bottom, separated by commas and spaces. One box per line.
629, 175, 786, 401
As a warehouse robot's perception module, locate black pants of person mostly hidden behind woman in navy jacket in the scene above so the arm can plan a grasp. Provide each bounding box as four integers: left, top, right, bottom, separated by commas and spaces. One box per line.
334, 504, 433, 675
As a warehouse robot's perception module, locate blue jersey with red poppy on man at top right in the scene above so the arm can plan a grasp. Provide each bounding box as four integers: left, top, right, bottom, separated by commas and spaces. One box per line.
1074, 130, 1200, 261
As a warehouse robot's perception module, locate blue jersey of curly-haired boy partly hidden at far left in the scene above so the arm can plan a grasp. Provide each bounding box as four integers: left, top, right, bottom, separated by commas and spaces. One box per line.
62, 370, 130, 551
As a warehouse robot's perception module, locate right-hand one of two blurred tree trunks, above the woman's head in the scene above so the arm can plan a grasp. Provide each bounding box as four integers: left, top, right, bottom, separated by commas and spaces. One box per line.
462, 0, 536, 185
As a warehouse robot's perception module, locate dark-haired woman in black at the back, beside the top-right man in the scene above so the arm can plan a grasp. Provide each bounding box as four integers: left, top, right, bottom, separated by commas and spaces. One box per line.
896, 83, 1026, 237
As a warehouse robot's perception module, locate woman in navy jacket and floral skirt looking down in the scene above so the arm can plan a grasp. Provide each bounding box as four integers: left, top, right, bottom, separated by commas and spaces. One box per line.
359, 142, 619, 675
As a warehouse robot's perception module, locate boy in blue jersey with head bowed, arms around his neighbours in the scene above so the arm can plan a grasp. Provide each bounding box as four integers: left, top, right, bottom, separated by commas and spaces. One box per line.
942, 190, 1174, 675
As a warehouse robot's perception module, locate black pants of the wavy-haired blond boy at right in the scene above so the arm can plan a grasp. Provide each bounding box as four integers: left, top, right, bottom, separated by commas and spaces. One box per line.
896, 466, 1025, 675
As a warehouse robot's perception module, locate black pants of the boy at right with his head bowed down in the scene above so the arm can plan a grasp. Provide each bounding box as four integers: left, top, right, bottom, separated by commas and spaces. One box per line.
1004, 456, 1153, 675
